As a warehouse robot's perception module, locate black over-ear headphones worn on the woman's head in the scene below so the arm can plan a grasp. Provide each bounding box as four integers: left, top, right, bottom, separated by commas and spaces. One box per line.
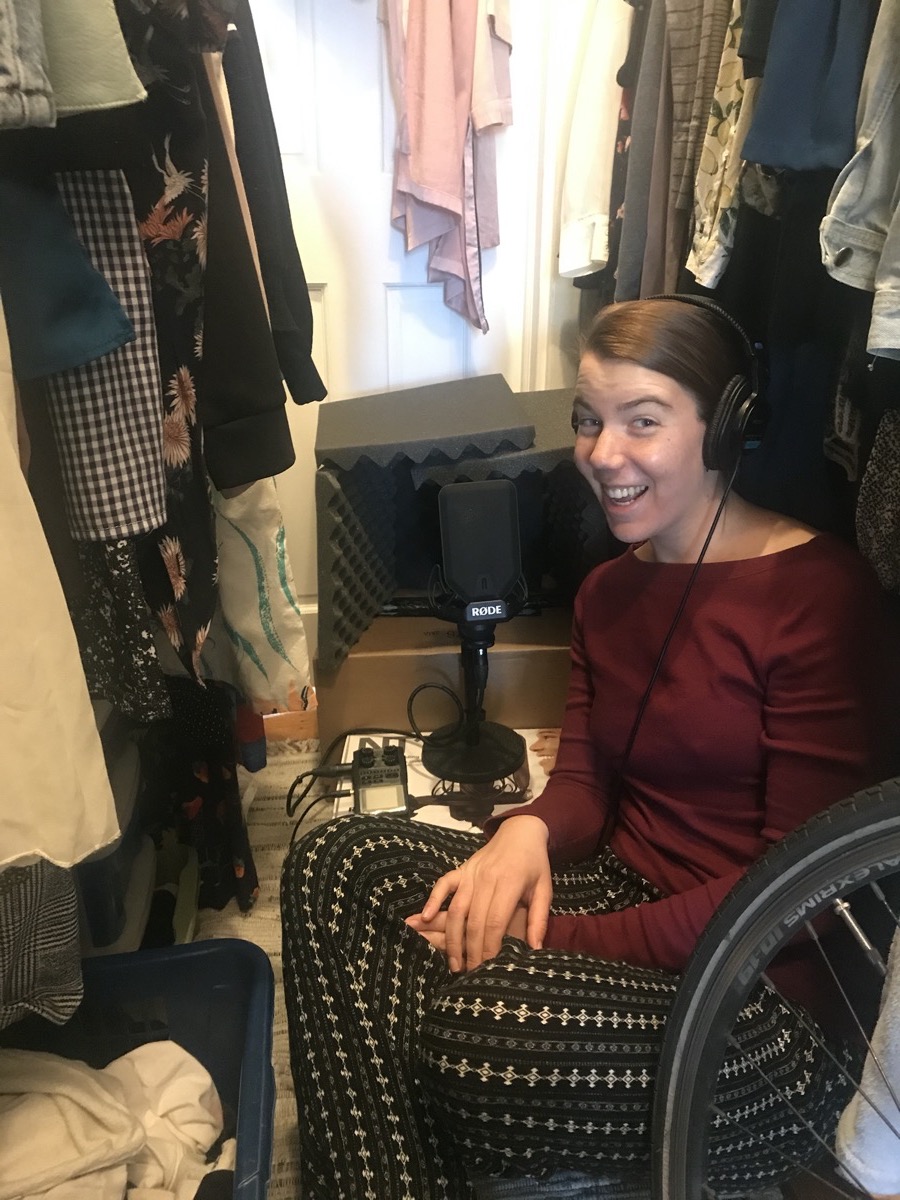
647, 293, 768, 475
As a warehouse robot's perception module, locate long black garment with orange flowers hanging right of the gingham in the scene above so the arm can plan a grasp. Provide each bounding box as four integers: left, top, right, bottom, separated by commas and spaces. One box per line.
118, 0, 224, 678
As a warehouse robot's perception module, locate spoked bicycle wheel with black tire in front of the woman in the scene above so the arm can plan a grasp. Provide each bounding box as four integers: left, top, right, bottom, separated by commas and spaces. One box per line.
652, 779, 900, 1200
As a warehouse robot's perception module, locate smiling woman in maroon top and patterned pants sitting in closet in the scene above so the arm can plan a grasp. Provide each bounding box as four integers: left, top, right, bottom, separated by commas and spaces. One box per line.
282, 299, 884, 1200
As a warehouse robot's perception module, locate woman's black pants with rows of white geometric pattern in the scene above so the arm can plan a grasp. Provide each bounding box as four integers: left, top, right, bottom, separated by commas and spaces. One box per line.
282, 816, 846, 1200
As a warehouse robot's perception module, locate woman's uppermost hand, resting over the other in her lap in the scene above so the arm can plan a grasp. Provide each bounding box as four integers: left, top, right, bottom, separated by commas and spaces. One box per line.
410, 812, 553, 971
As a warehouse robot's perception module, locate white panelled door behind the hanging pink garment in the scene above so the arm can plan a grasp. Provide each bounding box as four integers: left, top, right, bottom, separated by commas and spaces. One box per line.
253, 0, 594, 649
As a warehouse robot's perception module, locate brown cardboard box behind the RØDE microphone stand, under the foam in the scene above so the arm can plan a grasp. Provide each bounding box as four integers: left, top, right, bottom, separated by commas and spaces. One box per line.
316, 608, 572, 750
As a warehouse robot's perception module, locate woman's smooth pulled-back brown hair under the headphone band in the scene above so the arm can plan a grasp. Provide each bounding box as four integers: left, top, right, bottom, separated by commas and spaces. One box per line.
582, 300, 748, 425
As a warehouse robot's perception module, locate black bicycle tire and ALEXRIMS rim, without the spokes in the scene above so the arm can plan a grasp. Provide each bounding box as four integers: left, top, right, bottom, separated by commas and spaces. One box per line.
652, 779, 900, 1200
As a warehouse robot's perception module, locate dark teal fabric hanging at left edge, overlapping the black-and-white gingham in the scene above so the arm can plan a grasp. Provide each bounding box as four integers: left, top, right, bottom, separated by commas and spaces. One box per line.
0, 172, 134, 380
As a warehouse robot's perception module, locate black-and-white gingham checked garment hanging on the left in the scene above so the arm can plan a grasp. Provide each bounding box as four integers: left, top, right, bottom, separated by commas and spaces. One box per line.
47, 170, 166, 541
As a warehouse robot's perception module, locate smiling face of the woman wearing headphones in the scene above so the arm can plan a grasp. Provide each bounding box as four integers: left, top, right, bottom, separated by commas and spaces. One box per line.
572, 354, 722, 563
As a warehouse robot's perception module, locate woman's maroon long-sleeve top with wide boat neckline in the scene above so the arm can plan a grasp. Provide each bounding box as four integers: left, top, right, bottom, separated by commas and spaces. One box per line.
488, 535, 889, 971
